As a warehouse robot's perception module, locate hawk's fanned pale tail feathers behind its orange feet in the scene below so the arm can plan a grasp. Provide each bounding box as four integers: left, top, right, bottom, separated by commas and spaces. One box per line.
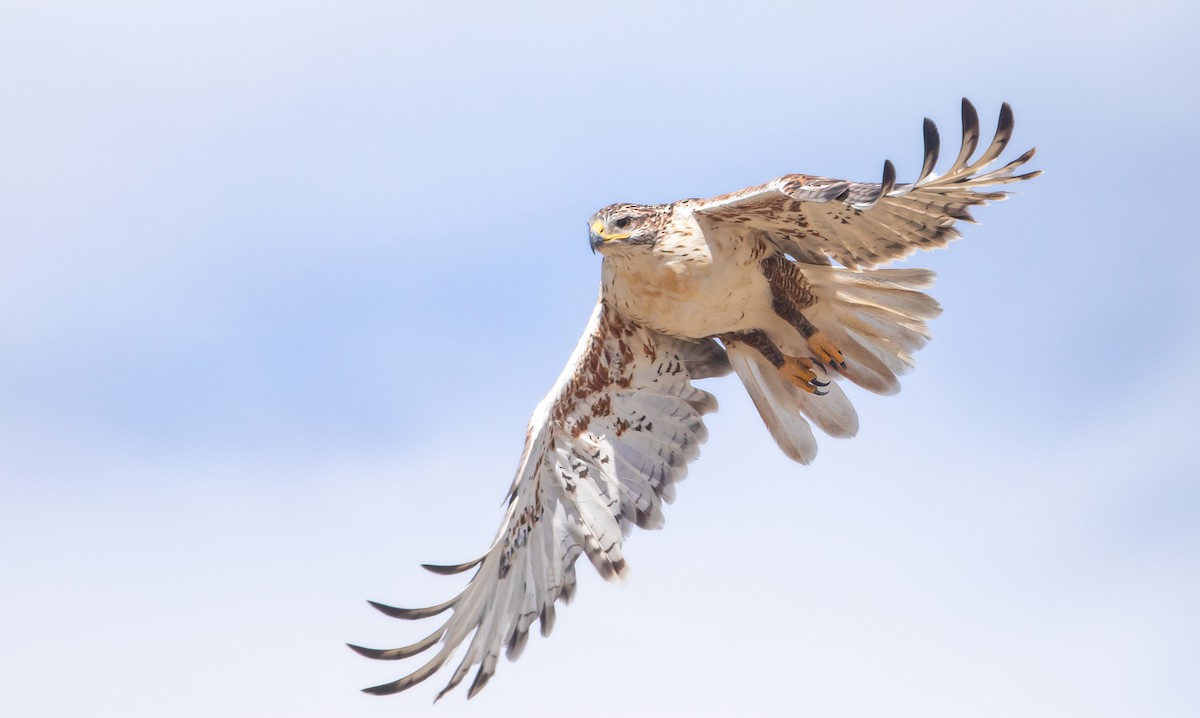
728, 265, 942, 463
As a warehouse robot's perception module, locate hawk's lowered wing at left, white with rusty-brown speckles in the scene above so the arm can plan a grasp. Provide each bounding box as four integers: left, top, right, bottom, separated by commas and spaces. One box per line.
350, 297, 730, 698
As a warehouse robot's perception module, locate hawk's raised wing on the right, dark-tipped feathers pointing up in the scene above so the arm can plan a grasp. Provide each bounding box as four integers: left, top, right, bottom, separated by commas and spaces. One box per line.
694, 98, 1042, 269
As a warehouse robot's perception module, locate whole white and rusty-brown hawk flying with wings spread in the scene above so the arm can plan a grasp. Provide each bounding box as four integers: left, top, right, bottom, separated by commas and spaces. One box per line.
350, 100, 1040, 698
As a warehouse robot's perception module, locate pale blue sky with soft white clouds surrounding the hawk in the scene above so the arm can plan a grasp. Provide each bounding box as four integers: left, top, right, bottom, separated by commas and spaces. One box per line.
0, 0, 1200, 718
